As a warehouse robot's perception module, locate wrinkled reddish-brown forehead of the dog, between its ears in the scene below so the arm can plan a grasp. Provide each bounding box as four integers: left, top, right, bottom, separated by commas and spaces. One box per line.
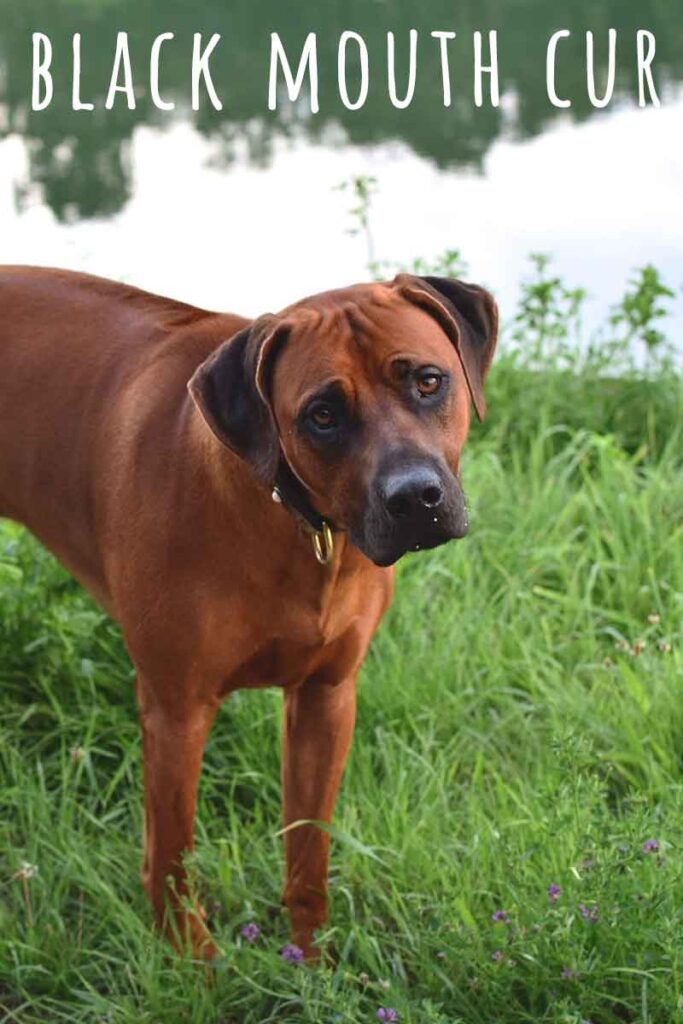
274, 285, 459, 398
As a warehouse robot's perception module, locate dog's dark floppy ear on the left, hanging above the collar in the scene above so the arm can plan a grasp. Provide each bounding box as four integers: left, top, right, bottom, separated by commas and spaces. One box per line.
187, 316, 288, 483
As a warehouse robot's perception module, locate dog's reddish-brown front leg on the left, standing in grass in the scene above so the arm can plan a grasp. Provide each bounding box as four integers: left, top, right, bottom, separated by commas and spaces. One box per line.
138, 678, 218, 958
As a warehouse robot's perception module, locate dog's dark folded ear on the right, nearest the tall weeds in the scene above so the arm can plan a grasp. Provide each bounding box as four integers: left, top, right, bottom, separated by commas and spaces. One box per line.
393, 273, 498, 420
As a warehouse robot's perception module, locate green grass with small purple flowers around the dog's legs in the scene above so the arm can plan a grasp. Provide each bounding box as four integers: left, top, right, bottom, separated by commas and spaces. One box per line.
0, 258, 683, 1024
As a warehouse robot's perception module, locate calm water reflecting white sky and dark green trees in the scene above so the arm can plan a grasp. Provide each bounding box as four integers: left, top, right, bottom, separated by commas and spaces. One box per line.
0, 0, 683, 337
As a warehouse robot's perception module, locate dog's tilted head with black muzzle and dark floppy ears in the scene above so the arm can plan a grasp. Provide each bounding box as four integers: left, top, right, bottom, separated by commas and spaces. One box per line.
189, 274, 498, 565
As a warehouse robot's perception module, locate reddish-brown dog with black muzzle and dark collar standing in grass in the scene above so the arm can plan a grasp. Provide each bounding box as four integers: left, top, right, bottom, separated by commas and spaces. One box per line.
0, 267, 498, 956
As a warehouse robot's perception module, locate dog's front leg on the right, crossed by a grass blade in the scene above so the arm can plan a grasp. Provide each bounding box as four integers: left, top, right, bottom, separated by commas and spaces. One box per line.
282, 673, 355, 958
